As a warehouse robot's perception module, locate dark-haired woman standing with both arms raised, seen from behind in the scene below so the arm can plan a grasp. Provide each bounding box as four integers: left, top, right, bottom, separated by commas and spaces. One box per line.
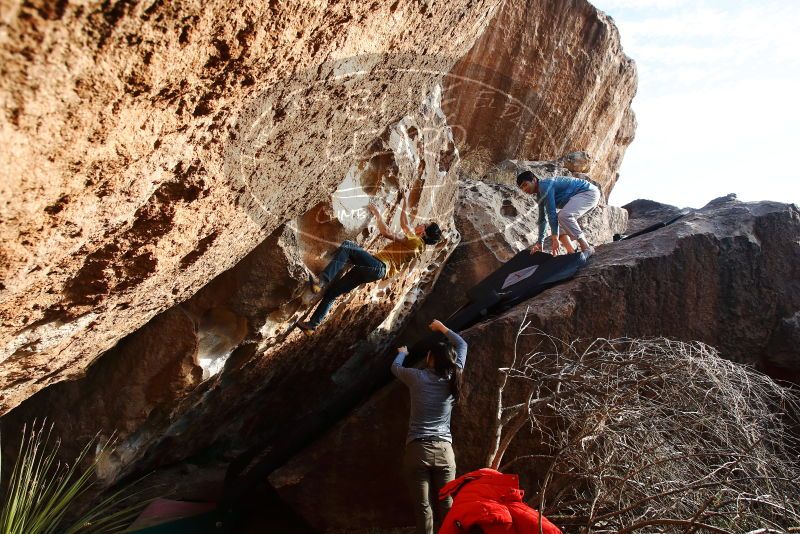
392, 320, 467, 534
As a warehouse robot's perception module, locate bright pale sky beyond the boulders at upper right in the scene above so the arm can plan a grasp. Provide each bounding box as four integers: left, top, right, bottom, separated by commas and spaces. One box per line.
590, 0, 800, 208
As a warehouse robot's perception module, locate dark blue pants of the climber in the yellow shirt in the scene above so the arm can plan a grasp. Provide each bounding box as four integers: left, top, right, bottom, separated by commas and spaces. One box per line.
309, 241, 386, 327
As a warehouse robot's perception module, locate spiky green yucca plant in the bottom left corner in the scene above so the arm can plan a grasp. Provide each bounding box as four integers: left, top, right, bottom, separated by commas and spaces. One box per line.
0, 422, 146, 534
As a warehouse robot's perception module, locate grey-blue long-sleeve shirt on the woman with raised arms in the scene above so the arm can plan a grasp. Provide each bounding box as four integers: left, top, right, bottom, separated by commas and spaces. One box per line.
392, 330, 467, 443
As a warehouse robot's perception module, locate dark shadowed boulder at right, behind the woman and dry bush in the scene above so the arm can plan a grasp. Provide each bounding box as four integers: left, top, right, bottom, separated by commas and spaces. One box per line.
270, 197, 800, 529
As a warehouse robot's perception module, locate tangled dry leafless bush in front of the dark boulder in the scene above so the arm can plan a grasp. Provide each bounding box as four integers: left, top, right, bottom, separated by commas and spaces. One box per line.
487, 312, 800, 533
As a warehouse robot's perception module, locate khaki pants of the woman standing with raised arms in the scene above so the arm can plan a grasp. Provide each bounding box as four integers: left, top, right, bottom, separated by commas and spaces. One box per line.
403, 441, 456, 534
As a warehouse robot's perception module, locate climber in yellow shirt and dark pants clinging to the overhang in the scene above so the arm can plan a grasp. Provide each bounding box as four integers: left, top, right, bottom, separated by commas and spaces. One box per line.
297, 193, 442, 334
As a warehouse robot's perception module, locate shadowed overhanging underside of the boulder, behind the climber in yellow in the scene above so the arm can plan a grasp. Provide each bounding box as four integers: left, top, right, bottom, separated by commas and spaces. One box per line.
3, 82, 468, 482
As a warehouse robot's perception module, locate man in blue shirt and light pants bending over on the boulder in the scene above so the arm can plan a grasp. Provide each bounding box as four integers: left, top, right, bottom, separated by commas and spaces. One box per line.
517, 171, 600, 257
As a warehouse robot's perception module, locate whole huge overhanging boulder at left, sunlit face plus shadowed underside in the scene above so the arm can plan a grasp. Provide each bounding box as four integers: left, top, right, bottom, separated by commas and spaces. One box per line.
0, 0, 633, 520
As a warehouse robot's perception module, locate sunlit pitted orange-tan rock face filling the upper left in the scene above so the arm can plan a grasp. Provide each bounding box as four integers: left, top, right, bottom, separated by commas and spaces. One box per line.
0, 0, 497, 412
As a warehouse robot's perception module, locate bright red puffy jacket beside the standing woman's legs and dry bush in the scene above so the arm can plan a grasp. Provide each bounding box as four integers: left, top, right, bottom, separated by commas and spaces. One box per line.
439, 469, 561, 534
